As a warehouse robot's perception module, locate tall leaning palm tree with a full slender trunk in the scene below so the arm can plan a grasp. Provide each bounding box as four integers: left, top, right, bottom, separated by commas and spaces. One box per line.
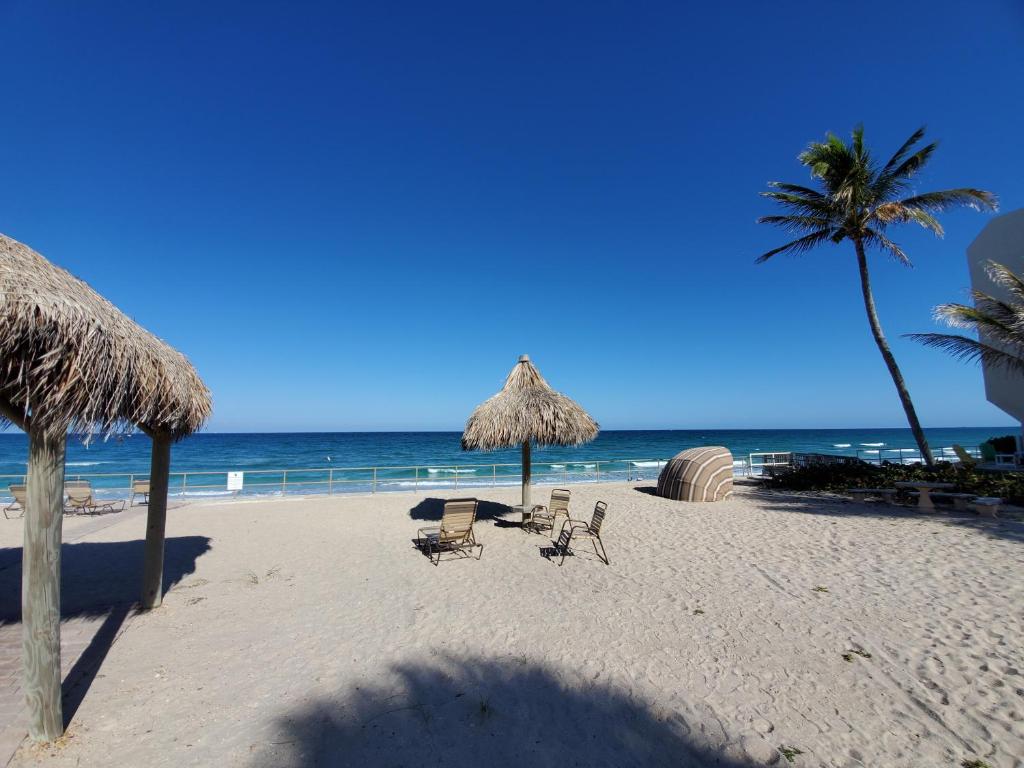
757, 126, 996, 466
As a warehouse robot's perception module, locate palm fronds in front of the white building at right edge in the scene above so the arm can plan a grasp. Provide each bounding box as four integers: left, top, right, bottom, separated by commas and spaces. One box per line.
907, 261, 1024, 374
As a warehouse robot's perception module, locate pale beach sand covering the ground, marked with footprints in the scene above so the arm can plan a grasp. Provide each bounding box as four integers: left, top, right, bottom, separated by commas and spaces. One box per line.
13, 483, 1024, 768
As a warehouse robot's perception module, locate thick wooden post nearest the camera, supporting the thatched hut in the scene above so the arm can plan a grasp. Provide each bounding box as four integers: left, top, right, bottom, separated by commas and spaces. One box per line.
22, 428, 67, 741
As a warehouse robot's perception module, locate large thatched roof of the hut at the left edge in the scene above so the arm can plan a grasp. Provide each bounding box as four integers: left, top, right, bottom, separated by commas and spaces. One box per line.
0, 234, 212, 438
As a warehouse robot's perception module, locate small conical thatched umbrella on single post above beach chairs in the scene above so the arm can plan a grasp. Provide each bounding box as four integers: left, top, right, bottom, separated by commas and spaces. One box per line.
462, 354, 600, 510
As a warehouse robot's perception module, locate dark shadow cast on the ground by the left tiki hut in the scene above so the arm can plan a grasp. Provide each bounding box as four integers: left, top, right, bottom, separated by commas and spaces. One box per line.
0, 536, 210, 726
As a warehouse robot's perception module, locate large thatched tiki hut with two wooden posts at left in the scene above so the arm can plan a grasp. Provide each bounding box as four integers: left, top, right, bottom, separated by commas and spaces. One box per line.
0, 234, 211, 741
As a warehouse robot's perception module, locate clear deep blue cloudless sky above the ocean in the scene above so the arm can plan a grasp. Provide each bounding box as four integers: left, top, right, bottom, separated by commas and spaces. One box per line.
0, 0, 1024, 431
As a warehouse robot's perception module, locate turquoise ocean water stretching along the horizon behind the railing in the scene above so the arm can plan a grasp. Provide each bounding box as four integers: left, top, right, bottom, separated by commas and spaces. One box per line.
0, 427, 1014, 496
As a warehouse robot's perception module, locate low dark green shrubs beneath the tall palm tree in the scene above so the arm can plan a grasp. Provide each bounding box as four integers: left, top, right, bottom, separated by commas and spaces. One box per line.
765, 462, 1024, 505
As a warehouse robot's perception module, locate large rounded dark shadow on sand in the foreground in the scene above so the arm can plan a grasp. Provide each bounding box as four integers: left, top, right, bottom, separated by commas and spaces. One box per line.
251, 654, 754, 768
